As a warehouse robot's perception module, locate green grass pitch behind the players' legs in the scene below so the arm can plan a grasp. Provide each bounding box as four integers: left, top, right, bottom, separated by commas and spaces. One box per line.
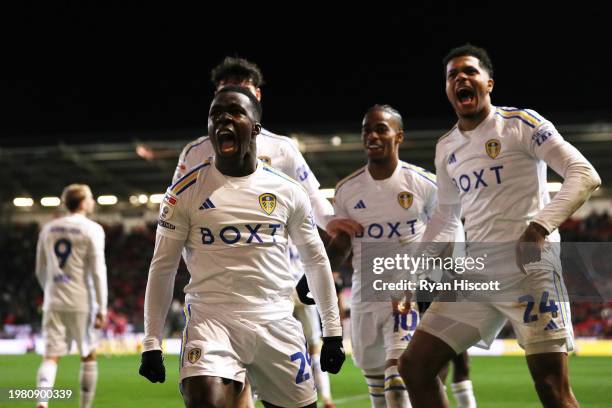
0, 354, 612, 408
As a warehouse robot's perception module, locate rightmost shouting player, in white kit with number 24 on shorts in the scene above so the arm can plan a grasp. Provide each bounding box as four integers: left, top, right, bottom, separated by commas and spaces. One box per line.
400, 44, 601, 408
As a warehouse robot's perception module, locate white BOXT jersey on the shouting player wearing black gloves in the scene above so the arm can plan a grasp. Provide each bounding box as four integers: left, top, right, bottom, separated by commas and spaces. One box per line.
158, 158, 319, 320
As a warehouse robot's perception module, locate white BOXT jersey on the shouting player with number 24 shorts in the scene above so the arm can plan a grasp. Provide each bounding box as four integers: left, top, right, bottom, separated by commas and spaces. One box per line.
435, 107, 567, 244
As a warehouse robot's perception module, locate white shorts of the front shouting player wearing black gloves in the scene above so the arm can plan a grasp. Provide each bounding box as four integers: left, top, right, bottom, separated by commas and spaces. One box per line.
180, 303, 317, 407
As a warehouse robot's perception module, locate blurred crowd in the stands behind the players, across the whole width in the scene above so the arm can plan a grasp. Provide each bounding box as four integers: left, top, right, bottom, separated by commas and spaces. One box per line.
0, 213, 612, 338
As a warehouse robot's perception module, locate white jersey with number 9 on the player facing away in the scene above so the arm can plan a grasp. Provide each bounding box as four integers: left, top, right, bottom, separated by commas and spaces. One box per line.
36, 214, 108, 313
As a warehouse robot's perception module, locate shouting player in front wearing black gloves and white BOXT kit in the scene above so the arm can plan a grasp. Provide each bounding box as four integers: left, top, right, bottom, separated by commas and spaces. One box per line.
140, 86, 344, 407
